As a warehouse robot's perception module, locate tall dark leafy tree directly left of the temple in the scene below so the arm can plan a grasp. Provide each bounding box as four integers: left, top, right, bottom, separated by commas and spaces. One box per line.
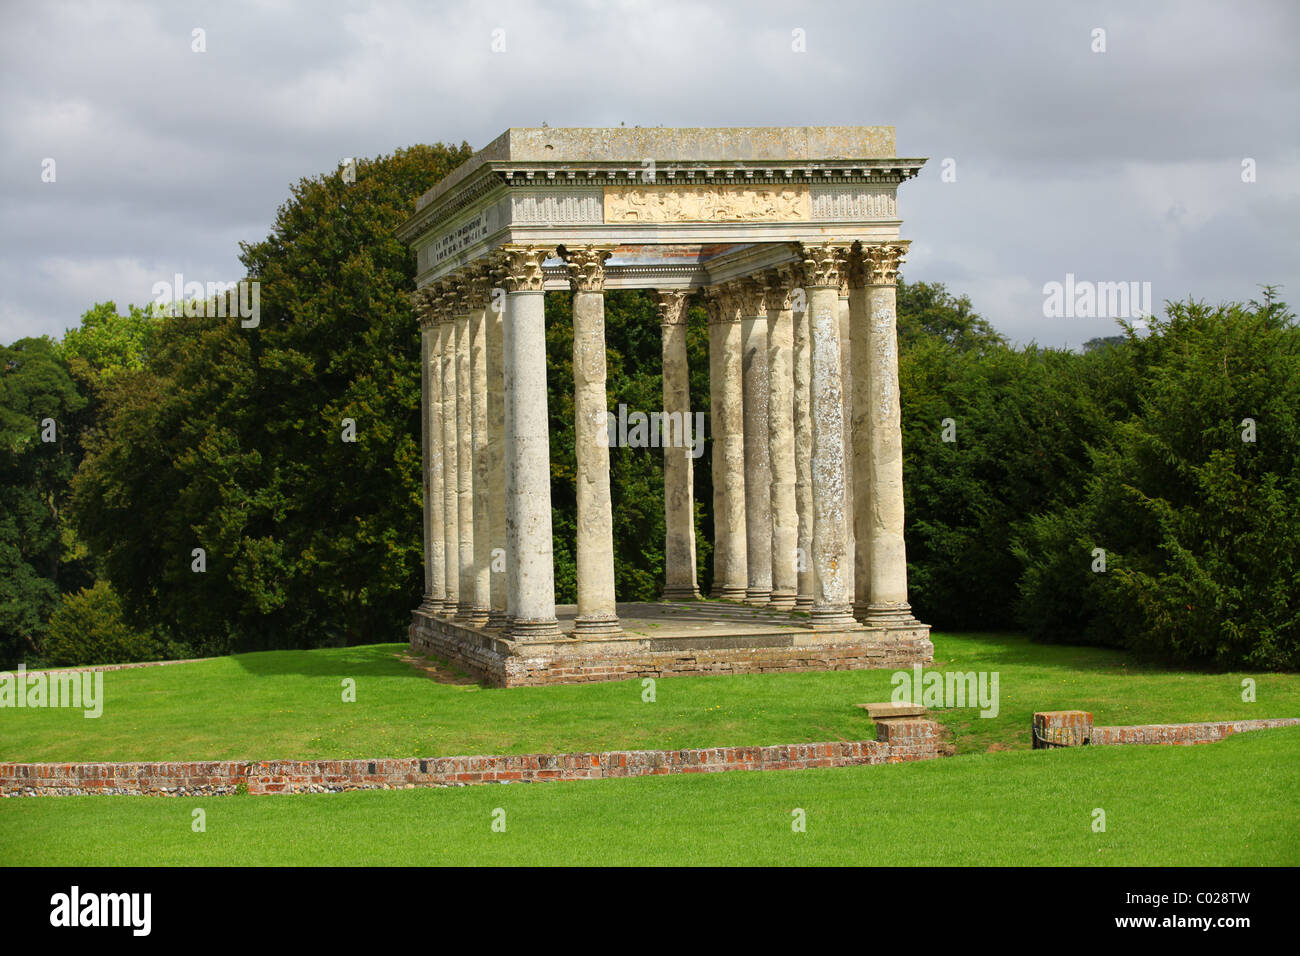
75, 144, 469, 653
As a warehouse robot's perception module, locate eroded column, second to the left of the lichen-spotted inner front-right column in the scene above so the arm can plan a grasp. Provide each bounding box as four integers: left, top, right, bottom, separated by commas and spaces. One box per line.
763, 269, 798, 610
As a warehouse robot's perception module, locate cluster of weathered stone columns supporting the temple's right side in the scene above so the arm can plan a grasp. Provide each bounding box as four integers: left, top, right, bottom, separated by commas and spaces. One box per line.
691, 242, 913, 630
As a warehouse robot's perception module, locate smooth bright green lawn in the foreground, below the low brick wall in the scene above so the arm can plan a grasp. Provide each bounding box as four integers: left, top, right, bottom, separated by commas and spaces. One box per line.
0, 728, 1300, 868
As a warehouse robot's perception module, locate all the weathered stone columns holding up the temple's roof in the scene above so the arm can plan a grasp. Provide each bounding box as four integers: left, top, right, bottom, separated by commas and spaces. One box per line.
416, 242, 911, 640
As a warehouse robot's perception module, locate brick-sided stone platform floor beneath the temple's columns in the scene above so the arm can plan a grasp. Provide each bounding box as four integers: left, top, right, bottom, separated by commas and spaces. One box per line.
410, 601, 935, 687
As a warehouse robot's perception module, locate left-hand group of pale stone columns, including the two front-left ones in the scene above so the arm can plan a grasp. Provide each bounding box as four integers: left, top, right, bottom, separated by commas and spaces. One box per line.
415, 246, 620, 640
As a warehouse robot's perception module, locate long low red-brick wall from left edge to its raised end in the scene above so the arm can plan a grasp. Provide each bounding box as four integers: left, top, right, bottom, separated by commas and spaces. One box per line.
0, 719, 939, 797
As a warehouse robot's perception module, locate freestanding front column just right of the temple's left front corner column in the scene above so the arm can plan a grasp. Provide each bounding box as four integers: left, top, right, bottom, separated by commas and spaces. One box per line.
560, 246, 623, 636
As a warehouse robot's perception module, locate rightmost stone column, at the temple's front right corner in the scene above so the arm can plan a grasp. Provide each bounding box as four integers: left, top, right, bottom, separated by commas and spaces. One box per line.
858, 241, 915, 626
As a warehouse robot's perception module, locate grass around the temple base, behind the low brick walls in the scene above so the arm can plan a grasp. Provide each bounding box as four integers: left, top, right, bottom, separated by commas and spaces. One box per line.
0, 635, 1300, 764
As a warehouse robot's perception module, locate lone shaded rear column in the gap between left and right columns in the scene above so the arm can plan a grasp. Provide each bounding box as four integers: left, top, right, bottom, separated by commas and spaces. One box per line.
659, 290, 705, 601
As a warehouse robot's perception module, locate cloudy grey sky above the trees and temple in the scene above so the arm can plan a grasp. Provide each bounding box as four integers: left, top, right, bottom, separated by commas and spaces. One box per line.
0, 0, 1300, 346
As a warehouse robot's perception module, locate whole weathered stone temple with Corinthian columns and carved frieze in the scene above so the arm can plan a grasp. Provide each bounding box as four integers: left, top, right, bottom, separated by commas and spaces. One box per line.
398, 126, 933, 685
